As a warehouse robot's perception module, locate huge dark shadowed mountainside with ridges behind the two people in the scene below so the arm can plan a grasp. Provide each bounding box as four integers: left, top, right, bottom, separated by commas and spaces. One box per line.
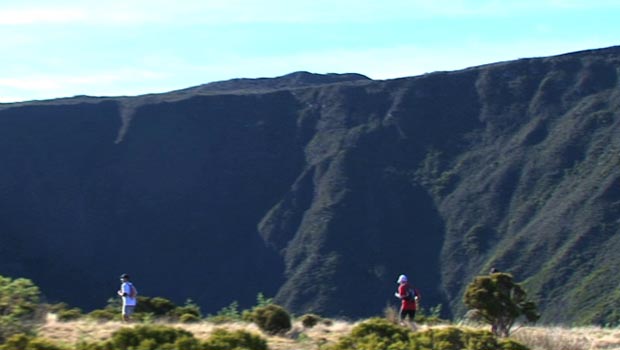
0, 47, 620, 322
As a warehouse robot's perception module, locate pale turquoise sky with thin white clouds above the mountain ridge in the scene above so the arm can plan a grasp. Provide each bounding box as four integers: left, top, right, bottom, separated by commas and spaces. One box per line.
0, 0, 620, 102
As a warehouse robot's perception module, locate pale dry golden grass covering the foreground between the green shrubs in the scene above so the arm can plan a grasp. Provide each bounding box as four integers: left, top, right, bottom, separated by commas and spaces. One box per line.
39, 315, 620, 350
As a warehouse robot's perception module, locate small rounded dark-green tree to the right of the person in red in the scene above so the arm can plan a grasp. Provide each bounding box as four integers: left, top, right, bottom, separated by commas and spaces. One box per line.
463, 273, 540, 337
